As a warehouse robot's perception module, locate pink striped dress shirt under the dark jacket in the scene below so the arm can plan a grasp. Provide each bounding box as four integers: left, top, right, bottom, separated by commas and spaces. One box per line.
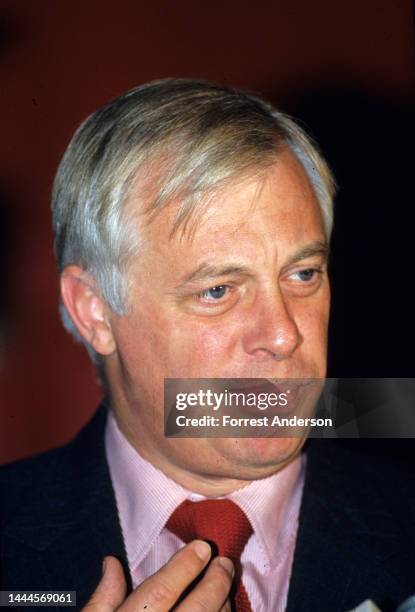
105, 413, 305, 612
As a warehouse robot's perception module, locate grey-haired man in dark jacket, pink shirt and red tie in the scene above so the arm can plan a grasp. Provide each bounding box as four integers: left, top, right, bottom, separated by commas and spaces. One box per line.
1, 79, 414, 611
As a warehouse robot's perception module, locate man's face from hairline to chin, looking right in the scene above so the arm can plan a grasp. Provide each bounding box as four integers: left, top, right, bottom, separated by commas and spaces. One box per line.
106, 151, 330, 492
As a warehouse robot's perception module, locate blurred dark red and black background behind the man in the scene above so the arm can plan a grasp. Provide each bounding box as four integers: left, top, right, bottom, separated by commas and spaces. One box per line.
0, 0, 415, 463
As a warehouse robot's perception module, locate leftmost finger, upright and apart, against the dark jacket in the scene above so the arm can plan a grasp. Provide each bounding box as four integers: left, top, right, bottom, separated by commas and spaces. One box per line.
82, 557, 127, 612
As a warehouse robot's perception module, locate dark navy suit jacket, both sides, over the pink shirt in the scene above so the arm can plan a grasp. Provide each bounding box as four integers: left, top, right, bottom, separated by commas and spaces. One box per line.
0, 408, 415, 612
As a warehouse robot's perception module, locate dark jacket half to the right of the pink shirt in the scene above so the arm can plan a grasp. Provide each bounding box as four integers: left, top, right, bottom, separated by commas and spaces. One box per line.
287, 440, 413, 612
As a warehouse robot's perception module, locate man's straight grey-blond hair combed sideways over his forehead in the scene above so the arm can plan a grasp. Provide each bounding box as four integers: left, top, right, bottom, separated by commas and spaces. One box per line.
52, 79, 335, 363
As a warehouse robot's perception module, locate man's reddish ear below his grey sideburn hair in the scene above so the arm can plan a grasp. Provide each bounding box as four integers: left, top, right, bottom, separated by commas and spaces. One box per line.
61, 266, 116, 355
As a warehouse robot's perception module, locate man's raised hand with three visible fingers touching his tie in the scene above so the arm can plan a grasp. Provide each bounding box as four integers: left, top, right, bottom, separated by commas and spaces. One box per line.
83, 540, 234, 612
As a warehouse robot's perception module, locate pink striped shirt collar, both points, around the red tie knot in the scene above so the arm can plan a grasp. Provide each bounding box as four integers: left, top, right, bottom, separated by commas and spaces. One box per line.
105, 411, 305, 568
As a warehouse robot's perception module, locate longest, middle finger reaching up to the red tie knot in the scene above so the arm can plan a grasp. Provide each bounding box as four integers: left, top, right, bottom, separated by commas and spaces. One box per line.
121, 540, 211, 612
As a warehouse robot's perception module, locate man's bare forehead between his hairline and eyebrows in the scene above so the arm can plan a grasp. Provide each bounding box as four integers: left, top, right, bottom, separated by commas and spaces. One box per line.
130, 150, 324, 263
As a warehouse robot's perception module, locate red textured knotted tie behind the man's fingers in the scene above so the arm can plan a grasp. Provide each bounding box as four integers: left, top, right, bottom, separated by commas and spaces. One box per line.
166, 499, 252, 612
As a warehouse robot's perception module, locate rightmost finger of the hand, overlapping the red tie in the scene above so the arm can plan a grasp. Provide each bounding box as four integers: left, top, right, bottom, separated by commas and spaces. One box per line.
177, 557, 235, 612
